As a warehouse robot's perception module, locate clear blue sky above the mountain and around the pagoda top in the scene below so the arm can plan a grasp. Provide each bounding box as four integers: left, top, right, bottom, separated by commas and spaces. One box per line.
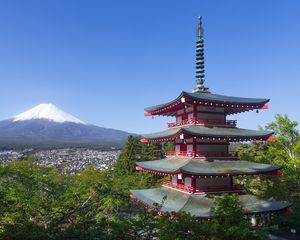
0, 0, 300, 133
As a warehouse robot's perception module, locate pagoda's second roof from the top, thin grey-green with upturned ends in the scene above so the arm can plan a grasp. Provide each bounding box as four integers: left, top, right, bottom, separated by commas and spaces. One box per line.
142, 125, 273, 141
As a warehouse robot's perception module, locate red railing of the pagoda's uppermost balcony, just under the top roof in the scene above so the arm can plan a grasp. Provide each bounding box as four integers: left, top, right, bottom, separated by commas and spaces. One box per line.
168, 118, 237, 128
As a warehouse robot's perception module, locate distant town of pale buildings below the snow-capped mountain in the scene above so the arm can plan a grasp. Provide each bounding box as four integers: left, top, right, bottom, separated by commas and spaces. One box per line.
0, 148, 120, 174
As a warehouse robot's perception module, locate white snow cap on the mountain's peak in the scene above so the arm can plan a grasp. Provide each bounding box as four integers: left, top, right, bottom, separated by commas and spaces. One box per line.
13, 103, 86, 125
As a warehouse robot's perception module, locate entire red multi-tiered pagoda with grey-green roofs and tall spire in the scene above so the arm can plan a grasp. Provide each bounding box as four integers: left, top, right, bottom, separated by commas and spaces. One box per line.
131, 17, 290, 223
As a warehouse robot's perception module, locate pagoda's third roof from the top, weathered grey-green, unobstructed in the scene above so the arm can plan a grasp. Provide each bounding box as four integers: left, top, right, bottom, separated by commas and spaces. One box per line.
136, 158, 281, 176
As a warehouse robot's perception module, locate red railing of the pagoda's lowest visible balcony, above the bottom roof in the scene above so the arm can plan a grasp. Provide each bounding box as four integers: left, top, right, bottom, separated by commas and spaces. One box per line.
162, 180, 244, 193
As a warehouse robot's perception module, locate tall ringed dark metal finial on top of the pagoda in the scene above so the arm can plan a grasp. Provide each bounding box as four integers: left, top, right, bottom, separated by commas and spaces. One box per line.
193, 16, 209, 93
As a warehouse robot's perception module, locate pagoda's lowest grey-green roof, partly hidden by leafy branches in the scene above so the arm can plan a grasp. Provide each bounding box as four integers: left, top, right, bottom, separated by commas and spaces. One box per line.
131, 187, 291, 218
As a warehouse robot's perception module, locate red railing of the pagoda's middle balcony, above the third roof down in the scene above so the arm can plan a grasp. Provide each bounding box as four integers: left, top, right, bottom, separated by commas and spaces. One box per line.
166, 151, 238, 158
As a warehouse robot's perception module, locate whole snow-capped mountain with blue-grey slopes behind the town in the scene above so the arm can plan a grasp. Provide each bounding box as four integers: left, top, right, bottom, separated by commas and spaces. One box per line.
0, 104, 130, 148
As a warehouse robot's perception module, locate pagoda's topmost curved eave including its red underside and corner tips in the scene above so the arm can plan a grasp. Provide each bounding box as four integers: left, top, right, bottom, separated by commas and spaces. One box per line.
144, 91, 270, 116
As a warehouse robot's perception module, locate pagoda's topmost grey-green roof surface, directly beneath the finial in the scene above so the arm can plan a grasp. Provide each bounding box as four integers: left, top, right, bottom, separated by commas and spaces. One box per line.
144, 91, 270, 115
